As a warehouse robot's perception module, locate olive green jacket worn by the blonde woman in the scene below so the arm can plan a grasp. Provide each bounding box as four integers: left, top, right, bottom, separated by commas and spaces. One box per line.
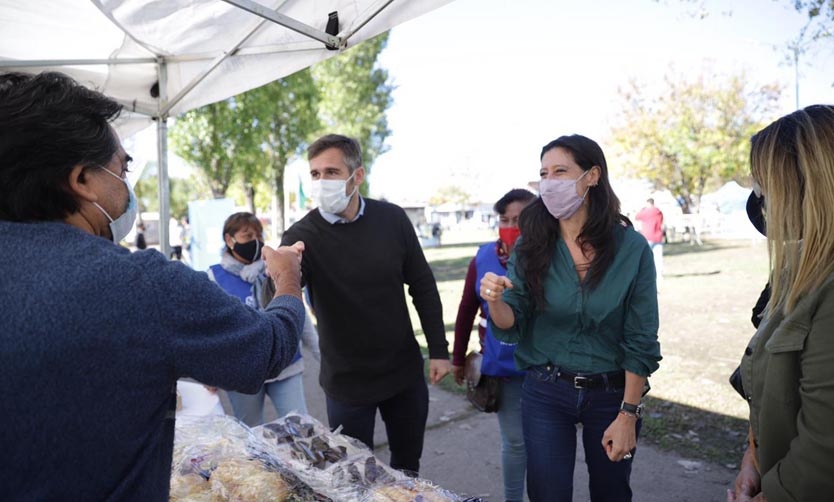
741, 275, 834, 502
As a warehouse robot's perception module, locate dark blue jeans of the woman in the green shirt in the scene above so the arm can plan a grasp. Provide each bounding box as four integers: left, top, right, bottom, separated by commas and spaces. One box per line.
521, 366, 640, 502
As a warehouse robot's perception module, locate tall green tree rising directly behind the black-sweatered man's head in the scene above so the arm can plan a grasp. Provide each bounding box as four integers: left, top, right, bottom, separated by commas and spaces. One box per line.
313, 32, 394, 194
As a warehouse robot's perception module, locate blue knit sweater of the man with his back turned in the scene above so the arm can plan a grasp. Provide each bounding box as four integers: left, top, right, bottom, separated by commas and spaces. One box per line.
0, 221, 304, 501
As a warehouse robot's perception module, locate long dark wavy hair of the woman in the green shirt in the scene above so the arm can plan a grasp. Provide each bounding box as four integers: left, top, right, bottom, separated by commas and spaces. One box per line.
516, 134, 630, 309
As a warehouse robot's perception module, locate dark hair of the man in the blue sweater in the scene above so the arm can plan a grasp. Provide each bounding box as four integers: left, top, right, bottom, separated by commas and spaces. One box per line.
0, 72, 121, 221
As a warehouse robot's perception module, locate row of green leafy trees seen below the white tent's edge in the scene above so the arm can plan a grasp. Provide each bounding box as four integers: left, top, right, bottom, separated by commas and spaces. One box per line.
171, 33, 393, 234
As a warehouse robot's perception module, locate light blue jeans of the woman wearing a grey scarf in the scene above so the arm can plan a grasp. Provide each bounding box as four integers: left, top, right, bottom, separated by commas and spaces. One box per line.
227, 373, 307, 427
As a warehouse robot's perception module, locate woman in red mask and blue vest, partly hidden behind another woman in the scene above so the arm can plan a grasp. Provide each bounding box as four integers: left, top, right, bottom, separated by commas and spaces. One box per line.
452, 188, 536, 501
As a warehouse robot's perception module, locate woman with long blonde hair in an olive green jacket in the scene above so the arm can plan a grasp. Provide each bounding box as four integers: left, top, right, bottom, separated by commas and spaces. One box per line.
727, 105, 834, 502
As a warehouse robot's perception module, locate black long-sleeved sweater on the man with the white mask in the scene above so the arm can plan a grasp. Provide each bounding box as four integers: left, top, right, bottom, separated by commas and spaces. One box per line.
281, 199, 449, 404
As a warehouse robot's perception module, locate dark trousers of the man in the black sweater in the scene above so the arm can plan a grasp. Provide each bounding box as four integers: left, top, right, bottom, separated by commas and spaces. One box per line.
326, 378, 429, 476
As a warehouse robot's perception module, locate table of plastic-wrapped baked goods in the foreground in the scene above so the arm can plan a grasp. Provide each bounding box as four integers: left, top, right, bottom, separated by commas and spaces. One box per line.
170, 413, 480, 502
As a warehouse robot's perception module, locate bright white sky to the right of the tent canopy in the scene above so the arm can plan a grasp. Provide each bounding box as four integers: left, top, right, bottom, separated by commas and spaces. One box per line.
370, 0, 834, 202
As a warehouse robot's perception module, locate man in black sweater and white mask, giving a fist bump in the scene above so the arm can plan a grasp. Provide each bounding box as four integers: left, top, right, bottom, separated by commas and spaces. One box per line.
282, 134, 450, 475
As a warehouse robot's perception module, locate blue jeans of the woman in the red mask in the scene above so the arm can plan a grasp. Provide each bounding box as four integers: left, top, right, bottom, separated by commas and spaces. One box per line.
498, 375, 527, 502
